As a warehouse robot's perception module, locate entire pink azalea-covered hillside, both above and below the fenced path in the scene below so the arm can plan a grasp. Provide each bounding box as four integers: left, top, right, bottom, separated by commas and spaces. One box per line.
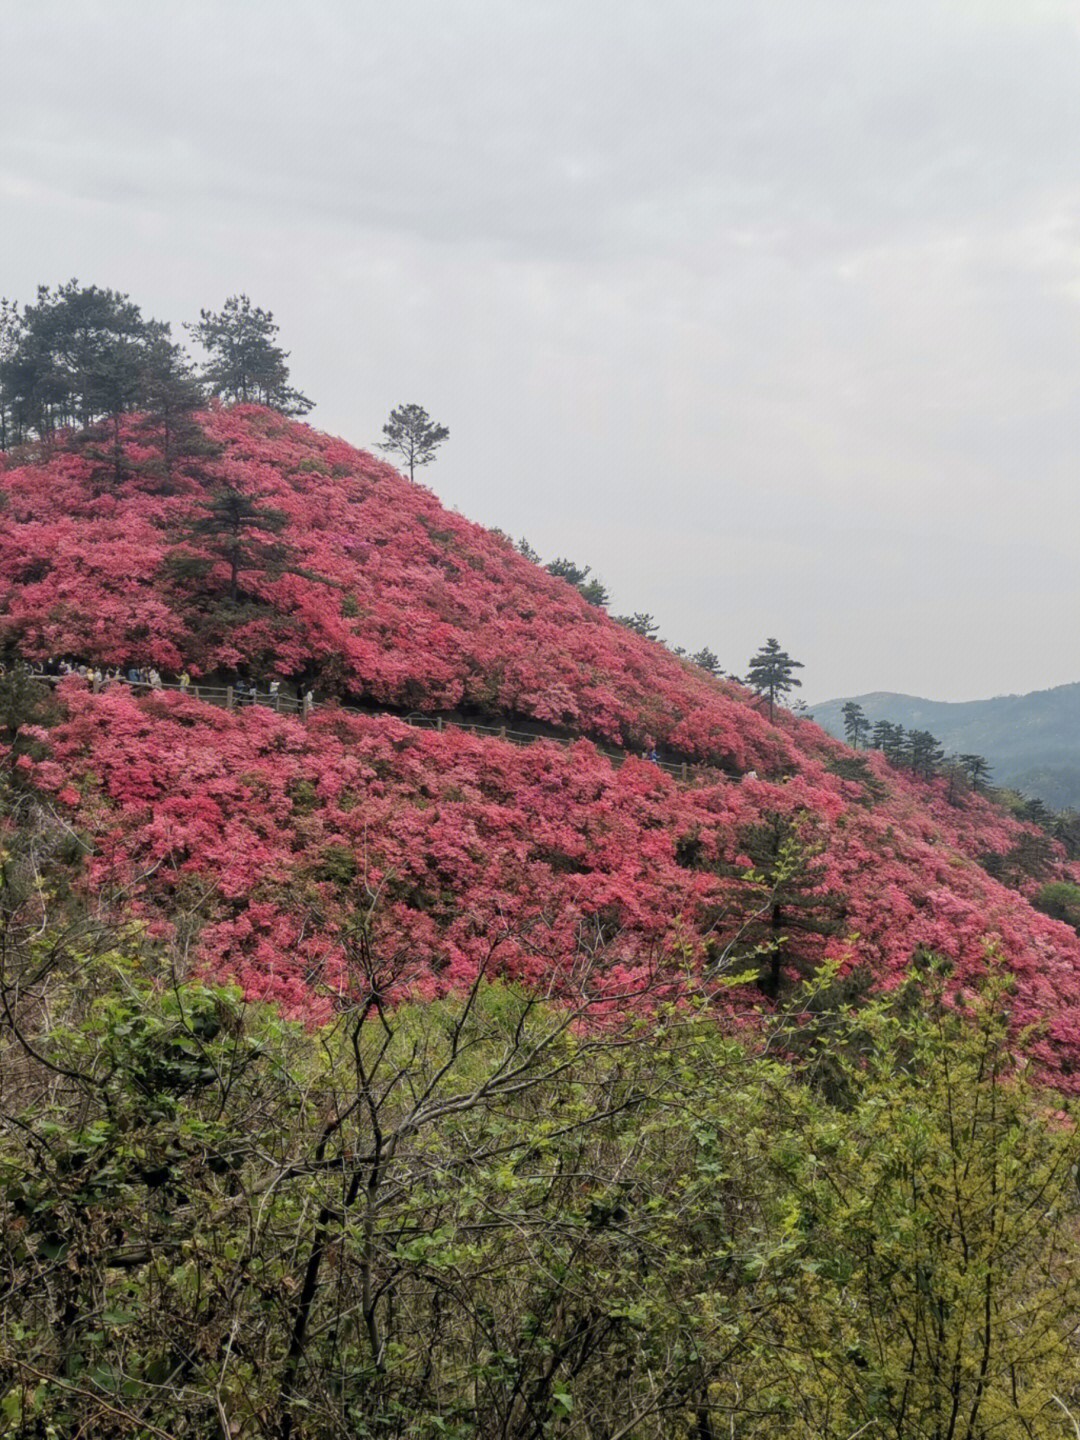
0, 408, 1080, 1084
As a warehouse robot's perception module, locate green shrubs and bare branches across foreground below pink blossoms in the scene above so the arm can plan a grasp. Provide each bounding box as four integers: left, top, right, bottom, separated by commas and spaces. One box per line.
0, 808, 1080, 1440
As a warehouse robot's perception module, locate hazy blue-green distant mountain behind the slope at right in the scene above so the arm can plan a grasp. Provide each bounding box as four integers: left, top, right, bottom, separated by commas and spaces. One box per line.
811, 684, 1080, 809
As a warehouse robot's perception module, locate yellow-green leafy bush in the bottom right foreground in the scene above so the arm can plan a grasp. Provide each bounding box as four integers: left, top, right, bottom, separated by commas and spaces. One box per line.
785, 966, 1080, 1440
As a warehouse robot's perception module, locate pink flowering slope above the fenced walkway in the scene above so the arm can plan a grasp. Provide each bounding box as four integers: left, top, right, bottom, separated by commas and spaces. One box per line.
0, 406, 791, 769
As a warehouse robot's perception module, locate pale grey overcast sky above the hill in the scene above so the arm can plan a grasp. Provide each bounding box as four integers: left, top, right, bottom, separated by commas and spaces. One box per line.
0, 0, 1080, 700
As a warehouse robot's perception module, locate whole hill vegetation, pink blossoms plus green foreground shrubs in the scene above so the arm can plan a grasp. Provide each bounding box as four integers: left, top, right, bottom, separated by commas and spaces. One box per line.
0, 368, 1080, 1440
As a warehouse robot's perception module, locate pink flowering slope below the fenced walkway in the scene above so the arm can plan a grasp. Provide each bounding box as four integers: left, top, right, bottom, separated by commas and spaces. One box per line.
16, 680, 1080, 1083
